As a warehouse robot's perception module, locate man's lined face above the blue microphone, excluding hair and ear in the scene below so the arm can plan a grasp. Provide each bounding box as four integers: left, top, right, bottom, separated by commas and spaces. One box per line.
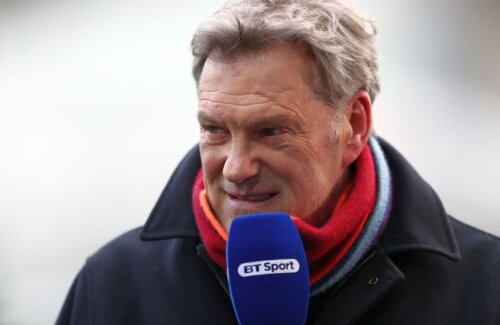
198, 44, 346, 230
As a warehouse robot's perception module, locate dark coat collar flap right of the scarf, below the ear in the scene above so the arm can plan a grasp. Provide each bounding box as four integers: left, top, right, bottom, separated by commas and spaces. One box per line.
379, 139, 460, 260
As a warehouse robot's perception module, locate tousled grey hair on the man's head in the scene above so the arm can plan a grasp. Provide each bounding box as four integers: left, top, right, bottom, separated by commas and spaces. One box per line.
191, 0, 379, 104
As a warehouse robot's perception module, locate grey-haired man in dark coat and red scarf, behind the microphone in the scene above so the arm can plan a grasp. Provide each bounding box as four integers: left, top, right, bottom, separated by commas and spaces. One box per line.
58, 0, 500, 324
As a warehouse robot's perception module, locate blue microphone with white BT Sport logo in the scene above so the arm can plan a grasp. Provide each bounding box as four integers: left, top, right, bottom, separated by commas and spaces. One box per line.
226, 213, 309, 325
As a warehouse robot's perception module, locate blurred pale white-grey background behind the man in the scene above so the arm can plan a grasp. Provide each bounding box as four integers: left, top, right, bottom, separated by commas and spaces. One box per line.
0, 0, 500, 325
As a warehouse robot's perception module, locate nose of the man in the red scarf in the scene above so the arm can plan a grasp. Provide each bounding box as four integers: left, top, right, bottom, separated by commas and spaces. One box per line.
222, 141, 260, 184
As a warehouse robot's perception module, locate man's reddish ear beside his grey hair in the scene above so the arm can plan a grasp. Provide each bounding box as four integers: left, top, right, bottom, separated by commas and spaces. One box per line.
342, 90, 372, 168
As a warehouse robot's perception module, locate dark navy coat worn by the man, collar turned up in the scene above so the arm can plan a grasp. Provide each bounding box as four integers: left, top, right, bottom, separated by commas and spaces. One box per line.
57, 140, 500, 325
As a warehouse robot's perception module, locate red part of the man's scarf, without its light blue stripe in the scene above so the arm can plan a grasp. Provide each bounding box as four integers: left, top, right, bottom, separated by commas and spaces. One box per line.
192, 146, 376, 285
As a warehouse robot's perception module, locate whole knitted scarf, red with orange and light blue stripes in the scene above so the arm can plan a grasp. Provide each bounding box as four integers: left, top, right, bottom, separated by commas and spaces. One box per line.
192, 138, 391, 295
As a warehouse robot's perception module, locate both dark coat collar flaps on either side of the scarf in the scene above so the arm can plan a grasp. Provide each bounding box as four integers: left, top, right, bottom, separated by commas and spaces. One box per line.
141, 138, 460, 259
